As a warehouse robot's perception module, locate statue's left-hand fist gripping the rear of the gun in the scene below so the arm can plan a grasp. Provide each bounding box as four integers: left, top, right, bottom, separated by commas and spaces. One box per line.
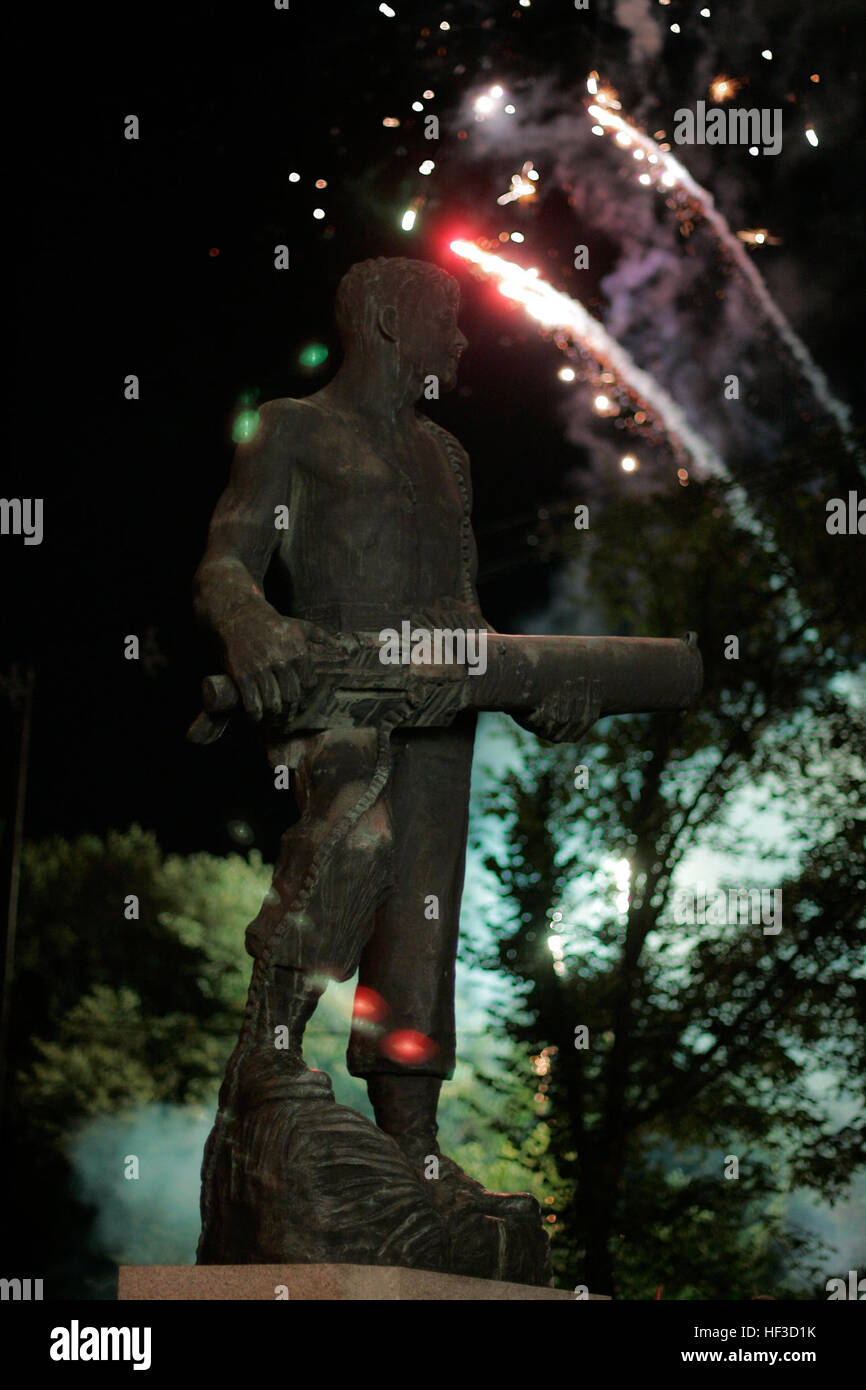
224, 603, 339, 720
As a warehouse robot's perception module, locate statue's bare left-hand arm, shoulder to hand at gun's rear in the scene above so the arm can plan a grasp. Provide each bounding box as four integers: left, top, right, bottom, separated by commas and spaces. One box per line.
193, 400, 318, 719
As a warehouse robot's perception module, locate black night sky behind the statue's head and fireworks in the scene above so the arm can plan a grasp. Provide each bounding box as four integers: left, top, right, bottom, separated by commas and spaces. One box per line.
0, 0, 865, 856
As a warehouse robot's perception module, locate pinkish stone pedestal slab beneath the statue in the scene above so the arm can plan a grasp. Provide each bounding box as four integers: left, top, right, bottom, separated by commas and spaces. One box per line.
118, 1265, 609, 1302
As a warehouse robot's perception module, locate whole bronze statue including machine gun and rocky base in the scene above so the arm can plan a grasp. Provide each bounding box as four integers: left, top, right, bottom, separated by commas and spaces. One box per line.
190, 259, 701, 1283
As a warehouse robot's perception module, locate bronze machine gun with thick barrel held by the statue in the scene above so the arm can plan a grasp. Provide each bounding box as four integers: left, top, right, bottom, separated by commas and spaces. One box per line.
188, 632, 703, 744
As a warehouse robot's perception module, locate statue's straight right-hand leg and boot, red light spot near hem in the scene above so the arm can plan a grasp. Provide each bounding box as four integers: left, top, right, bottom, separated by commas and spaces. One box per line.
348, 716, 538, 1220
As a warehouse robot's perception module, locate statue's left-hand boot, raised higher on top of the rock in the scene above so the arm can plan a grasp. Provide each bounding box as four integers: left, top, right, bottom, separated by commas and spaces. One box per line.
238, 962, 334, 1109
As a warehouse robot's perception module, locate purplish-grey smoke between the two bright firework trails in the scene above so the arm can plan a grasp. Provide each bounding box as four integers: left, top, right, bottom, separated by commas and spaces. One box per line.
459, 59, 856, 503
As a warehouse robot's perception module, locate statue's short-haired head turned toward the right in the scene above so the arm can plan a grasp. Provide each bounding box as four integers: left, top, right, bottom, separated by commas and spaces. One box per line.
336, 256, 467, 391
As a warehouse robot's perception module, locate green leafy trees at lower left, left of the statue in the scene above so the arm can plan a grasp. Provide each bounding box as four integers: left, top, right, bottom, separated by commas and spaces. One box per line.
3, 827, 268, 1297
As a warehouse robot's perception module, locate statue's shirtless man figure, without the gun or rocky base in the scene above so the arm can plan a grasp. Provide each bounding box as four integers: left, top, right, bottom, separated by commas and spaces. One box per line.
196, 259, 595, 1213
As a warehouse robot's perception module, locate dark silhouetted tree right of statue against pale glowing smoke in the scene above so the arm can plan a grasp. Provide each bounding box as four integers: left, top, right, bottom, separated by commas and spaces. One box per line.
475, 439, 866, 1298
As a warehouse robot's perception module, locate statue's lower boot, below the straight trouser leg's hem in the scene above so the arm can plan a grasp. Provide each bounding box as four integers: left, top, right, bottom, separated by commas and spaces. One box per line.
367, 1074, 541, 1220
